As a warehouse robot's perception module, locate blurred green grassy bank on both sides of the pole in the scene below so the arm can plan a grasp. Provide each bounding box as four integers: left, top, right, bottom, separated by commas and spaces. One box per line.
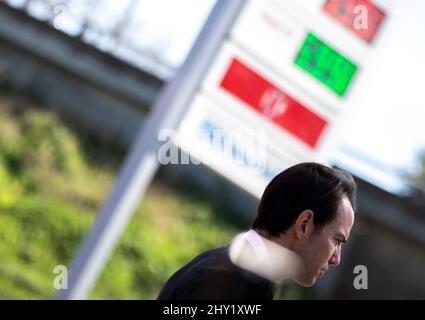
0, 98, 237, 299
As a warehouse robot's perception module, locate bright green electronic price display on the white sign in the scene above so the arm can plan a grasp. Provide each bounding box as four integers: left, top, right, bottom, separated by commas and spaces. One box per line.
294, 33, 357, 96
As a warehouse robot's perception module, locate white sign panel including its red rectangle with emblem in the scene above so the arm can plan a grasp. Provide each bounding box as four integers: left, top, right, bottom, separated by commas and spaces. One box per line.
201, 43, 337, 162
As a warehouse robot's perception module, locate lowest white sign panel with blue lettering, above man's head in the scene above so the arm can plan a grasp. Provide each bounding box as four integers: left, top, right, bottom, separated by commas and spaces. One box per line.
176, 94, 302, 198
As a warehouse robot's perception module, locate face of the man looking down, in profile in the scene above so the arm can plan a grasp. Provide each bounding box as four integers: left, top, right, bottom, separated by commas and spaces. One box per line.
294, 197, 354, 287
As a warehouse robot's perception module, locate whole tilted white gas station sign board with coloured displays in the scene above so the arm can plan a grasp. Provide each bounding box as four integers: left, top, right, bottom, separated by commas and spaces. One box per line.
176, 0, 394, 197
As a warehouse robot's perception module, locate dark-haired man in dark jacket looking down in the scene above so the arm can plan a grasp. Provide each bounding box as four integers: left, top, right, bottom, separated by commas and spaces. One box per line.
158, 163, 356, 300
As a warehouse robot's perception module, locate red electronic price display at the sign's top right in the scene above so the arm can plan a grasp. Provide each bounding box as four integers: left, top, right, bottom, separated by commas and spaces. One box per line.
323, 0, 385, 43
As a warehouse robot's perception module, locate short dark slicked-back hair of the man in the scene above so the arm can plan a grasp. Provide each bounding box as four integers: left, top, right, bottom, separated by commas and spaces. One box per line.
252, 162, 357, 236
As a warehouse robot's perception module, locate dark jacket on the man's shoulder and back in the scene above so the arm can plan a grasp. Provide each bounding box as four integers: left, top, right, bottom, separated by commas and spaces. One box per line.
158, 247, 274, 300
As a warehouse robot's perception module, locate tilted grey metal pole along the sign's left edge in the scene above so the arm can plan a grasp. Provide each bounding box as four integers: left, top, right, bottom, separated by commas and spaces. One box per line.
56, 0, 246, 299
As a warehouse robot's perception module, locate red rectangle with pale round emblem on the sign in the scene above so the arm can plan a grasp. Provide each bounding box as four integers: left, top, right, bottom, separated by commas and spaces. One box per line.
220, 59, 327, 148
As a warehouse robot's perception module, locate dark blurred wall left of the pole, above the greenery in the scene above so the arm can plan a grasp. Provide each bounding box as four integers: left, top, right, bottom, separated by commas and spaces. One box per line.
0, 2, 163, 144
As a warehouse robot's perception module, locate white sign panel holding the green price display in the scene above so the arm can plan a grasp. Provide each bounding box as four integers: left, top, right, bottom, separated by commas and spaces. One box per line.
231, 0, 362, 106
